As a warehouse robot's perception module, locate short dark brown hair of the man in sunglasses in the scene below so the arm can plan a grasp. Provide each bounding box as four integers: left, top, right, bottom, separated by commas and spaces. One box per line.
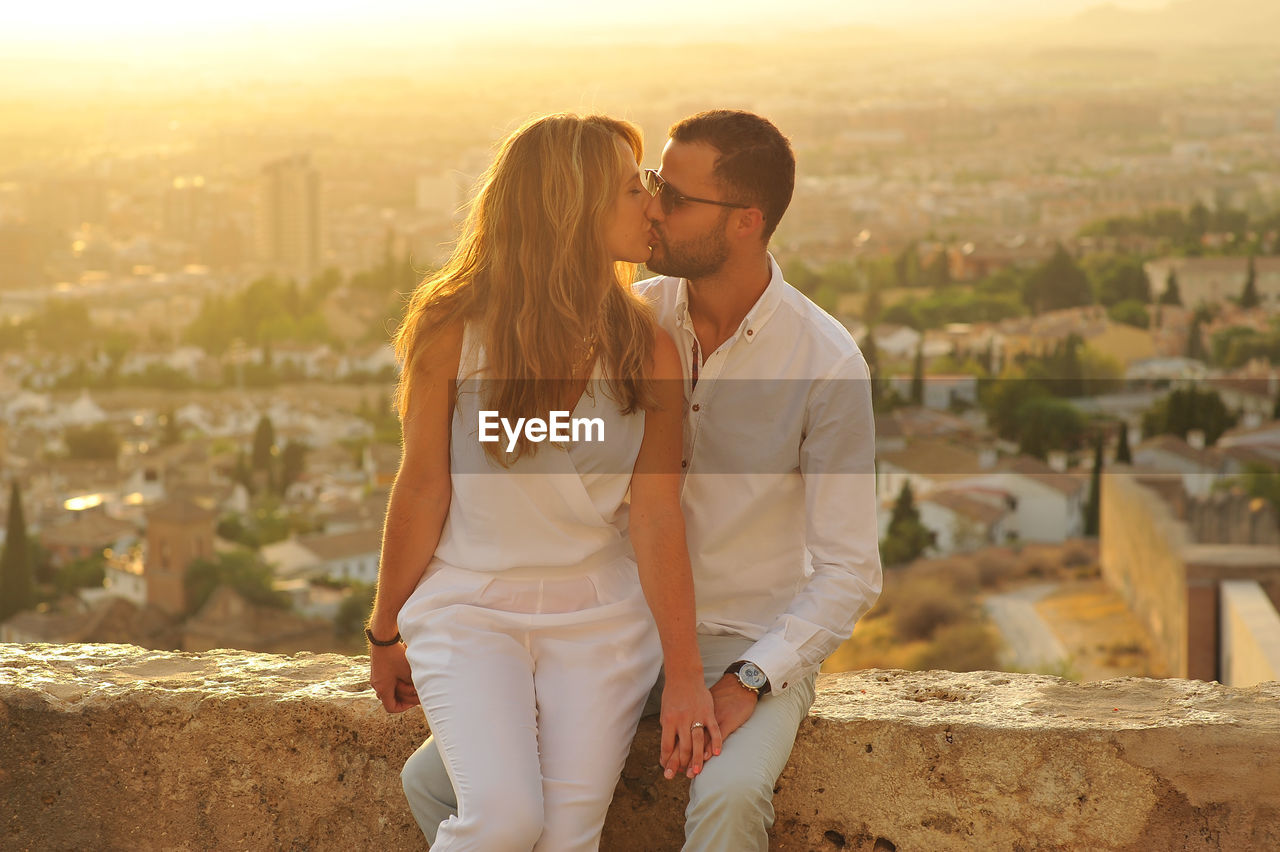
668, 110, 796, 242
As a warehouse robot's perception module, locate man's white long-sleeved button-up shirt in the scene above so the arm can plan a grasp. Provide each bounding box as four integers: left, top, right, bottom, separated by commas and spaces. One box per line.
636, 256, 881, 691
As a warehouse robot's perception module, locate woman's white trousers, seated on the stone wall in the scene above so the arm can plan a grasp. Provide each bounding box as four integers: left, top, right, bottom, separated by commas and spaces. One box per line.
399, 556, 662, 852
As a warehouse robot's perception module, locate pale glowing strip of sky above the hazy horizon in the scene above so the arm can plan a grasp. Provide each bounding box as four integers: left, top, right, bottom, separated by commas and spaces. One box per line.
0, 0, 1165, 50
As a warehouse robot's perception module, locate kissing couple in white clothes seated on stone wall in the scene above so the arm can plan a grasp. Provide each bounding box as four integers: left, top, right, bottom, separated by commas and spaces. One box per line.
366, 110, 881, 852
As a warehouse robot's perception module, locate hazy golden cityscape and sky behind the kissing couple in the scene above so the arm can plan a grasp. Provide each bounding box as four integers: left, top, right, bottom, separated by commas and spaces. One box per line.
0, 0, 1280, 683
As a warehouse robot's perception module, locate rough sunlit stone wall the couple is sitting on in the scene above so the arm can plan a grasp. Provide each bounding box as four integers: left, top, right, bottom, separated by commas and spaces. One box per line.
0, 645, 1280, 852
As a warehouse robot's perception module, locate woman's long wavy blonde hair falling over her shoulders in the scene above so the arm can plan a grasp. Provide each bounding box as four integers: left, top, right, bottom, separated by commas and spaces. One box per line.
394, 114, 655, 464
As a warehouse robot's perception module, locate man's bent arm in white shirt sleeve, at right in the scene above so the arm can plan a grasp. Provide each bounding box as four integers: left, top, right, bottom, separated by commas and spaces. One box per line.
739, 353, 881, 691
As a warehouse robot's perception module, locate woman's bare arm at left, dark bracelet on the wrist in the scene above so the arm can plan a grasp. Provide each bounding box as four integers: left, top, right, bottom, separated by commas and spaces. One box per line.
369, 322, 462, 713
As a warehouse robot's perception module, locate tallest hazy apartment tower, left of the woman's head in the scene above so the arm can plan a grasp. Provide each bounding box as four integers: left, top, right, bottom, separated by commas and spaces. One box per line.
257, 154, 320, 284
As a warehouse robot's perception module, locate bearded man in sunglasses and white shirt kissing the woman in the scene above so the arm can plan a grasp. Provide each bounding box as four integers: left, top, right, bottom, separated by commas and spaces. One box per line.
402, 110, 881, 852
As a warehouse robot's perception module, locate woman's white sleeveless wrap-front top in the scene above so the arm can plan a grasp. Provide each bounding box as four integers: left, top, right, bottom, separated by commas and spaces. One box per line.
433, 322, 644, 573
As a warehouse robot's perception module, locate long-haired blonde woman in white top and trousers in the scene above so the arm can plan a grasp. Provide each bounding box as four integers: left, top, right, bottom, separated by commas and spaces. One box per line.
369, 115, 721, 852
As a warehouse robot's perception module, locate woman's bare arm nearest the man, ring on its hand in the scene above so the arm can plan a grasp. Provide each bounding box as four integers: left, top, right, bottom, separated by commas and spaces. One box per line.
631, 324, 722, 778
